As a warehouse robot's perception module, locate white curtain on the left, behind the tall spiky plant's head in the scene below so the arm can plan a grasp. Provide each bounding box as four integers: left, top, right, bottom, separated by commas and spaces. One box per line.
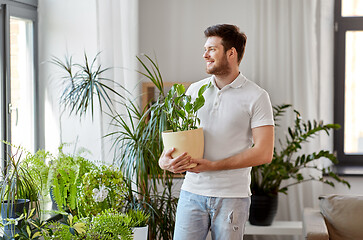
96, 0, 139, 163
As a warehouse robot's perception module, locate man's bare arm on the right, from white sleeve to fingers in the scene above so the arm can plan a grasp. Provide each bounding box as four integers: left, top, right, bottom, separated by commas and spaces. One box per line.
188, 125, 274, 173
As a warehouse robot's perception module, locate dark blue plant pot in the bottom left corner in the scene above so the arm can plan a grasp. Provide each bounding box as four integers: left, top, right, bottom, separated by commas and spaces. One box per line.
1, 199, 30, 239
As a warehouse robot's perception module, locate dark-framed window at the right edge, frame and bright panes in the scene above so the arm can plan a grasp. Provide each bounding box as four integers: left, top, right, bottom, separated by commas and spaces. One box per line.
334, 0, 363, 175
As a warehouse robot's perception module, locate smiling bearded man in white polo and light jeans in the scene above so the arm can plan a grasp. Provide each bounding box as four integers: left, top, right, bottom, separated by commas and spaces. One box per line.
159, 24, 274, 240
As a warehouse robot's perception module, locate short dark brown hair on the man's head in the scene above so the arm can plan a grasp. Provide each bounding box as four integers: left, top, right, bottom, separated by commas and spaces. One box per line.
204, 24, 247, 63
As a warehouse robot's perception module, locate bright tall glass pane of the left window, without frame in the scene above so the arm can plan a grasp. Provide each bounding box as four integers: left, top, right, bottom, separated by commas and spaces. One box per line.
8, 16, 35, 151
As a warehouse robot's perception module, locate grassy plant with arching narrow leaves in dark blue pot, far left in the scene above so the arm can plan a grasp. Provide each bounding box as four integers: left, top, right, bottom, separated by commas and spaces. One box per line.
0, 142, 39, 239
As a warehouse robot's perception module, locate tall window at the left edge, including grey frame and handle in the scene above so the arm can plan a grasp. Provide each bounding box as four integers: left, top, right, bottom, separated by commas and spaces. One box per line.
0, 0, 38, 163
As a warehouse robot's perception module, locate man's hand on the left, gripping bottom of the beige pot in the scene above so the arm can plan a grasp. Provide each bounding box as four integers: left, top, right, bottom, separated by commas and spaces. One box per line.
159, 148, 191, 173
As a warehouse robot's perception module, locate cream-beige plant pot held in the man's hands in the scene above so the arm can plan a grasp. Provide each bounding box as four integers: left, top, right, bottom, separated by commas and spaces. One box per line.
162, 128, 204, 168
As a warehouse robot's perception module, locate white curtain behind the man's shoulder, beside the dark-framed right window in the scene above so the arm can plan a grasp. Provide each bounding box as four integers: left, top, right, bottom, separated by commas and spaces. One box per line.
248, 0, 334, 239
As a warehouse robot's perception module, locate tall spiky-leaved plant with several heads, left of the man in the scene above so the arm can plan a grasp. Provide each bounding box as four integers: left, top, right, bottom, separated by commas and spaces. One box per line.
53, 54, 189, 239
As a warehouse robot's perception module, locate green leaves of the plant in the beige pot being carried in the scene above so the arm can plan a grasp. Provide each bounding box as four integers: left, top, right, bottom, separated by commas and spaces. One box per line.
163, 83, 211, 132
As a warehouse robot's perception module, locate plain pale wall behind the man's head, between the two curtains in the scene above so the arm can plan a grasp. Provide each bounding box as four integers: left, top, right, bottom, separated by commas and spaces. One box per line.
139, 0, 253, 85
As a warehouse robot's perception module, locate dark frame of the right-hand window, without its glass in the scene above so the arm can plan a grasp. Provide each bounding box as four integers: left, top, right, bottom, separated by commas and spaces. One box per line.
334, 0, 363, 176
